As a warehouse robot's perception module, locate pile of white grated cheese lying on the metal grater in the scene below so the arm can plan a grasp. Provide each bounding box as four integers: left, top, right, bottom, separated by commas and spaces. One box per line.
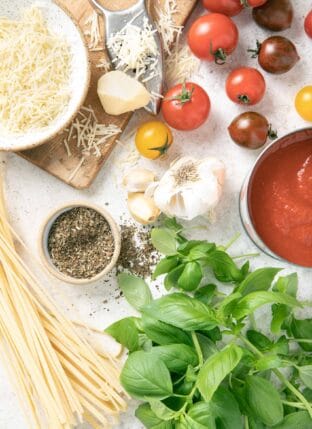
107, 16, 158, 83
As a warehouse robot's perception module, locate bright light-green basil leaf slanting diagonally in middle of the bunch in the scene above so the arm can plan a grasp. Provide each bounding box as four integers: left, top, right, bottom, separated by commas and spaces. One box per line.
197, 344, 243, 401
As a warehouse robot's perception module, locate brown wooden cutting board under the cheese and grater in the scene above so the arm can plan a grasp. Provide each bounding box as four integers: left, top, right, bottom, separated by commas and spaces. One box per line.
19, 0, 196, 189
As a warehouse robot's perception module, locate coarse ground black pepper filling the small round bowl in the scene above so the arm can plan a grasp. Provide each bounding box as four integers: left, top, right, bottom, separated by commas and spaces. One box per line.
48, 207, 115, 279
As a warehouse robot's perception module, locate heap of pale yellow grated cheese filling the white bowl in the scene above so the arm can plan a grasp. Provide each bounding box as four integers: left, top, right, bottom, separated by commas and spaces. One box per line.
0, 7, 71, 134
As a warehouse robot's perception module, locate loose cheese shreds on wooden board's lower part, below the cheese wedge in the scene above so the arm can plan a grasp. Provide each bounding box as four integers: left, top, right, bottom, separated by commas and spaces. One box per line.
63, 106, 122, 158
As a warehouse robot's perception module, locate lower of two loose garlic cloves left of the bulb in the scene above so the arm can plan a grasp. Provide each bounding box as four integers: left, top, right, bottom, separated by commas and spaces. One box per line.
128, 192, 160, 225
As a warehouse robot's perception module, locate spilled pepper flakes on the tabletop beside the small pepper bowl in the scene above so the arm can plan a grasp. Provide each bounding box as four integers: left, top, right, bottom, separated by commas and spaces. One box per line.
117, 223, 160, 277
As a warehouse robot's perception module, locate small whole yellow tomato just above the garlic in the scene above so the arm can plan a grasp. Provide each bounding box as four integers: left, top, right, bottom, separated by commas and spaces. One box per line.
135, 121, 173, 159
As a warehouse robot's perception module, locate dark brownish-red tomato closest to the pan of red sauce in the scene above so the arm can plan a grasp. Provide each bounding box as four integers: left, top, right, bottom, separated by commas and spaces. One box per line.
228, 112, 277, 149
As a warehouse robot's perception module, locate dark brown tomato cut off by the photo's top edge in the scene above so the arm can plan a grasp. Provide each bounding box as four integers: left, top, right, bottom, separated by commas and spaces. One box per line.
252, 0, 294, 31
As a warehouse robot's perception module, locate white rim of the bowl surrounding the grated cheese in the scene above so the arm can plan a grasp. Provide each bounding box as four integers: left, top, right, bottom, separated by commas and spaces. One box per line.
0, 0, 90, 151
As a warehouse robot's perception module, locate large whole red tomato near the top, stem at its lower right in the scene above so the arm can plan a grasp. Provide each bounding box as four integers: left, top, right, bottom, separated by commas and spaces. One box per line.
188, 13, 238, 64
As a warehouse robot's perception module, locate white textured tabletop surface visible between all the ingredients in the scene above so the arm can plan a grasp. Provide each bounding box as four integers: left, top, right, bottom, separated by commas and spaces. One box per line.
0, 0, 312, 429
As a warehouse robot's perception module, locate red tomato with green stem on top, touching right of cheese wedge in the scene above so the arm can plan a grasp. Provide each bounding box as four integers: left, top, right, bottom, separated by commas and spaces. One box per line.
161, 82, 210, 131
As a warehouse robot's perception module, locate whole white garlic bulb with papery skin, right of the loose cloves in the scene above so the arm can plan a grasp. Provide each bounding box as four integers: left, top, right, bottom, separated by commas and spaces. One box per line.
151, 156, 225, 220
